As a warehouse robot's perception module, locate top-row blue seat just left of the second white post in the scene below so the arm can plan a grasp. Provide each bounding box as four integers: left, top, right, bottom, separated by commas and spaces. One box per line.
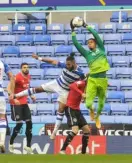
29, 12, 46, 23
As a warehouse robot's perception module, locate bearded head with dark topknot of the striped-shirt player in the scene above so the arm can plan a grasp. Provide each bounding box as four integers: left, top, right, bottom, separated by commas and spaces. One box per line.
66, 53, 76, 71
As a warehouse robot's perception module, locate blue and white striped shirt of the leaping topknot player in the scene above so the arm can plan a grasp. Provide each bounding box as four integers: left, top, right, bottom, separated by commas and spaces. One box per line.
56, 62, 84, 90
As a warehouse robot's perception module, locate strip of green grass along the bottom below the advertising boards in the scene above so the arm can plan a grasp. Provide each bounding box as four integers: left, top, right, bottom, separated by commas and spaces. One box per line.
0, 155, 132, 163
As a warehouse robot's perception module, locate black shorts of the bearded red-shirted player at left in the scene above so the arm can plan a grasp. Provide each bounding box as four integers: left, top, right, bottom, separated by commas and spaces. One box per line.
11, 104, 31, 121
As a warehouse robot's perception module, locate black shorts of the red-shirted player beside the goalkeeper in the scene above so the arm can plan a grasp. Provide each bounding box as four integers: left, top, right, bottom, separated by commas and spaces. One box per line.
65, 107, 87, 128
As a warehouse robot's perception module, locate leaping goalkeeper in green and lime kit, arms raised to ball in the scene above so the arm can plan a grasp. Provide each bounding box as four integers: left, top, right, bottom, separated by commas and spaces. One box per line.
70, 20, 110, 128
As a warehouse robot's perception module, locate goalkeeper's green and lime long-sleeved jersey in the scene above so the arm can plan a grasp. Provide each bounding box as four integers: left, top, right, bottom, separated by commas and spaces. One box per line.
72, 26, 110, 74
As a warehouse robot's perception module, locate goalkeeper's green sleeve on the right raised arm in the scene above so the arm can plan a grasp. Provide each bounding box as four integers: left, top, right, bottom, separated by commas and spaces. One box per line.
87, 26, 105, 51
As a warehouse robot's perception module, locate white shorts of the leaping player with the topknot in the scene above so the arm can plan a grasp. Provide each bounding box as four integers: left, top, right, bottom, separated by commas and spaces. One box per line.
41, 80, 69, 104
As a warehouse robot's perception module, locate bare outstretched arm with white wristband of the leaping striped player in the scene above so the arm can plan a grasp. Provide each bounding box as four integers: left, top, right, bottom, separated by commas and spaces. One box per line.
32, 54, 59, 65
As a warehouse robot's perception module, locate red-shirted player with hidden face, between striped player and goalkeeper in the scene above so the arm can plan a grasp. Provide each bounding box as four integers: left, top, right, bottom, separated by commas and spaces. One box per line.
60, 77, 90, 154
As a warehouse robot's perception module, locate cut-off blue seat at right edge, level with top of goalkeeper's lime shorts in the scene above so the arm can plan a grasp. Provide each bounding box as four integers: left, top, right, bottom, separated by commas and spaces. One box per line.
121, 80, 132, 91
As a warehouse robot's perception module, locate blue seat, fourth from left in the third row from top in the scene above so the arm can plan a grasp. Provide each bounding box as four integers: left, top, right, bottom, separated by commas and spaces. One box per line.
51, 34, 68, 45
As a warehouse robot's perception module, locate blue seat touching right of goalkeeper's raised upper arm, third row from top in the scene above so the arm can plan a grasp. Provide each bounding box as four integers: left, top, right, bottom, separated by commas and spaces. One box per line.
104, 34, 121, 44
